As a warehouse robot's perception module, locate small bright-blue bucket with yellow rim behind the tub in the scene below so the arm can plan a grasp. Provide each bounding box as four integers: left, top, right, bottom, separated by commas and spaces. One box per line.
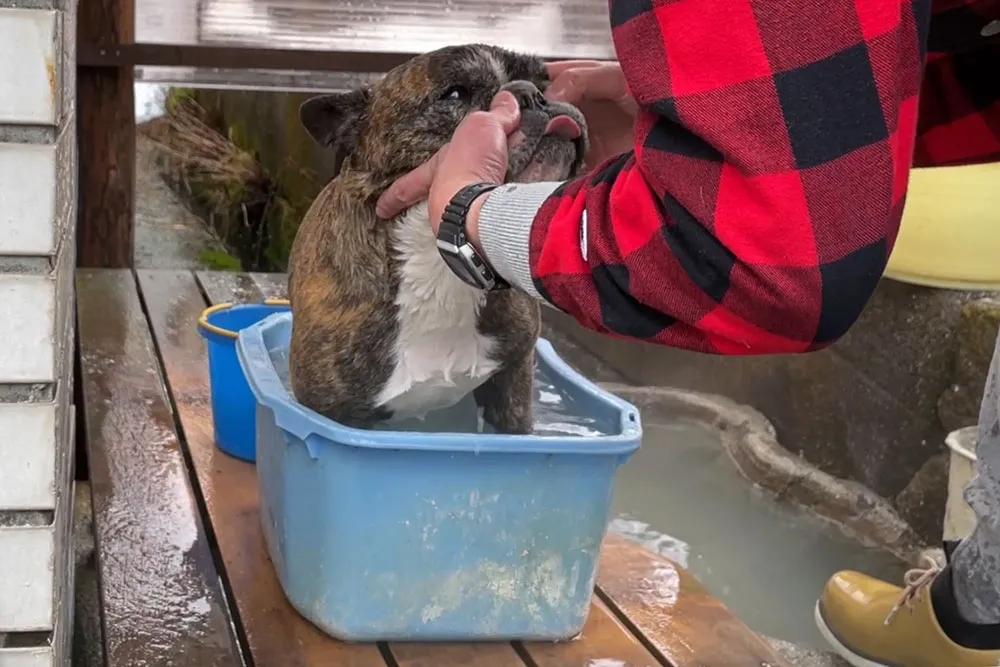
198, 299, 289, 463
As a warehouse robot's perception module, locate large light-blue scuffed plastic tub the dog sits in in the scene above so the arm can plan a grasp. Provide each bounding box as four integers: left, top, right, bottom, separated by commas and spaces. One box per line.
237, 314, 642, 641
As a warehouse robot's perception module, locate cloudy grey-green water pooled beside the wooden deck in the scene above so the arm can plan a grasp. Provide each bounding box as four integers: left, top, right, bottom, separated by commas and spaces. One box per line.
611, 422, 906, 648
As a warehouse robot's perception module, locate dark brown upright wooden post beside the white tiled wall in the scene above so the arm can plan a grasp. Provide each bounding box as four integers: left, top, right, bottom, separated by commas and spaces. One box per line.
76, 0, 135, 268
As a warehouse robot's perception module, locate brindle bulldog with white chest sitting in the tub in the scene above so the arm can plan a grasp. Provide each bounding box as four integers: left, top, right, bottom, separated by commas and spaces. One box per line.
289, 44, 587, 433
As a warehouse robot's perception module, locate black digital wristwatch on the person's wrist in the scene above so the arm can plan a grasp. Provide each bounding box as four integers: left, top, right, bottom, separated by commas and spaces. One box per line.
437, 183, 510, 292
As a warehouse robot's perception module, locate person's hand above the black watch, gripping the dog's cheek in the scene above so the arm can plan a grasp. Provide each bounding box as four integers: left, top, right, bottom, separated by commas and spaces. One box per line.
375, 91, 521, 250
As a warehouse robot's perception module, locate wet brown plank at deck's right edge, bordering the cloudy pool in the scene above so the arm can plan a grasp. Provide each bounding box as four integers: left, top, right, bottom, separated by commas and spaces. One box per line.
597, 535, 791, 667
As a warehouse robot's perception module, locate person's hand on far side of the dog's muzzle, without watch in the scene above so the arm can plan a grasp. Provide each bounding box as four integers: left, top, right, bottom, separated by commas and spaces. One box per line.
545, 60, 639, 168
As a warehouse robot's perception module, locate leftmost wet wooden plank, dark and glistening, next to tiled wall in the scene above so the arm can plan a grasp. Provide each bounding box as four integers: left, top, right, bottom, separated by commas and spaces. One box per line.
77, 270, 243, 667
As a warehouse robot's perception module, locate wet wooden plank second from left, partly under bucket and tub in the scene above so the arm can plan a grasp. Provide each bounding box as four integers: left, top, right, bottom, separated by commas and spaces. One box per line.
138, 271, 385, 667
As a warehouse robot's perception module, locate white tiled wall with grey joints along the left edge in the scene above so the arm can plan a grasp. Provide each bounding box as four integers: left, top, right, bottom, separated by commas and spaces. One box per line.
0, 0, 77, 667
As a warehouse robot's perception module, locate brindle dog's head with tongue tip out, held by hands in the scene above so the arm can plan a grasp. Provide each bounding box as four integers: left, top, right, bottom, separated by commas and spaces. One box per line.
300, 44, 587, 190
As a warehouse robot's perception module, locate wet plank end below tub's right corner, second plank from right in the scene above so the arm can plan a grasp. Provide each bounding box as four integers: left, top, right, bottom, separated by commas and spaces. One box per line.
524, 596, 660, 667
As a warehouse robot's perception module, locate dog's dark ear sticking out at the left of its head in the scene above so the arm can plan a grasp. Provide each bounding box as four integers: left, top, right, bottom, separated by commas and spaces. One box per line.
299, 88, 369, 173
